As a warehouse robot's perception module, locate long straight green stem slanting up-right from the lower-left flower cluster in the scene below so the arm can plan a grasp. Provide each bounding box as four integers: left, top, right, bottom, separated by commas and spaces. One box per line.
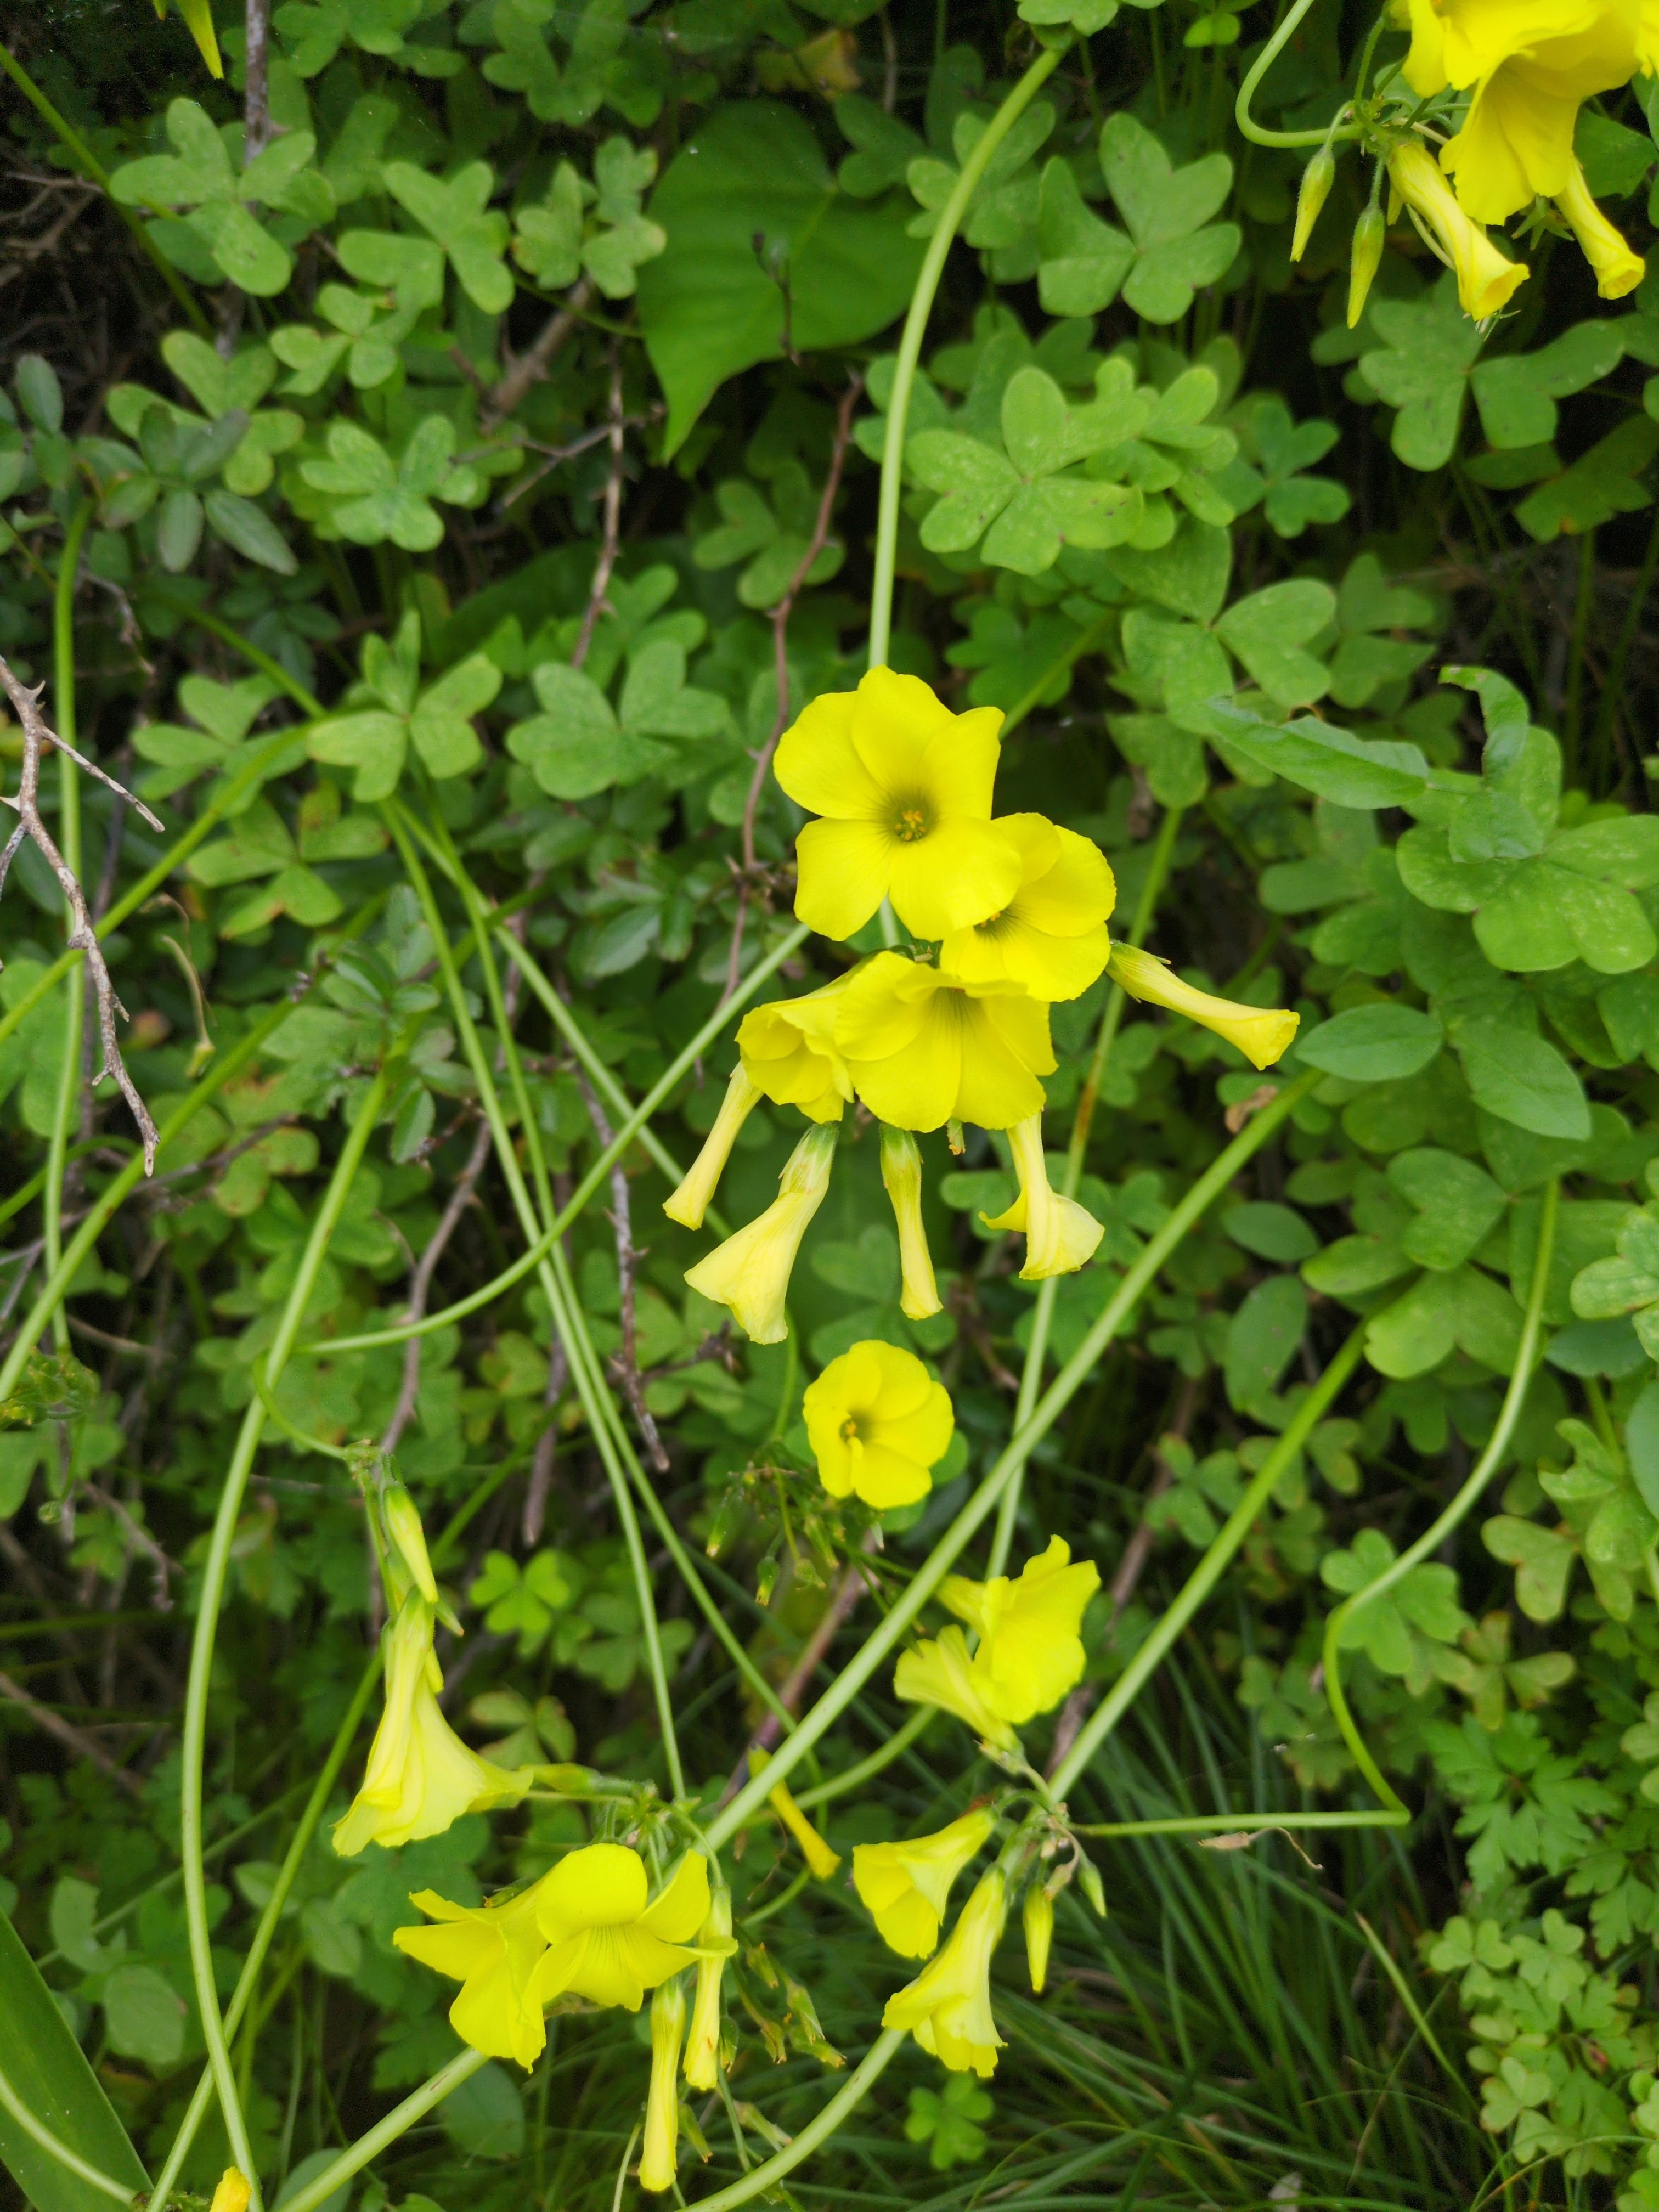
706, 1068, 1323, 1849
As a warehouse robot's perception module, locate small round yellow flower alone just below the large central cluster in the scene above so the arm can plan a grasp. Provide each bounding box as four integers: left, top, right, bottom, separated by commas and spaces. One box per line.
801, 1336, 956, 1513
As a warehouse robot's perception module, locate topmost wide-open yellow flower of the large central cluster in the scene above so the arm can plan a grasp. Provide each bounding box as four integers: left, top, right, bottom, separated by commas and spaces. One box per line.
776, 668, 1020, 938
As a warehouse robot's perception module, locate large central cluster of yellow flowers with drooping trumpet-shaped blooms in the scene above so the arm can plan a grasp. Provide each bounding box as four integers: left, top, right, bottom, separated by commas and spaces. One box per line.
664, 668, 1296, 1342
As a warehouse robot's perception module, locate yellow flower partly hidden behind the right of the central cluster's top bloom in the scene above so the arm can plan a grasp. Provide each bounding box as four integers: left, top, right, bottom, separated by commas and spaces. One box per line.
940, 814, 1117, 1000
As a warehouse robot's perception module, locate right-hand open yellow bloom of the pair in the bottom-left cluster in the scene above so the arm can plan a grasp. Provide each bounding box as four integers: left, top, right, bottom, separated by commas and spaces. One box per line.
531, 1843, 708, 2013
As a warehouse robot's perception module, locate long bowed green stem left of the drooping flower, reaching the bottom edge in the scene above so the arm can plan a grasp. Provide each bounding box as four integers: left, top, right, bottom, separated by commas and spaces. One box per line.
179, 1053, 402, 2212
